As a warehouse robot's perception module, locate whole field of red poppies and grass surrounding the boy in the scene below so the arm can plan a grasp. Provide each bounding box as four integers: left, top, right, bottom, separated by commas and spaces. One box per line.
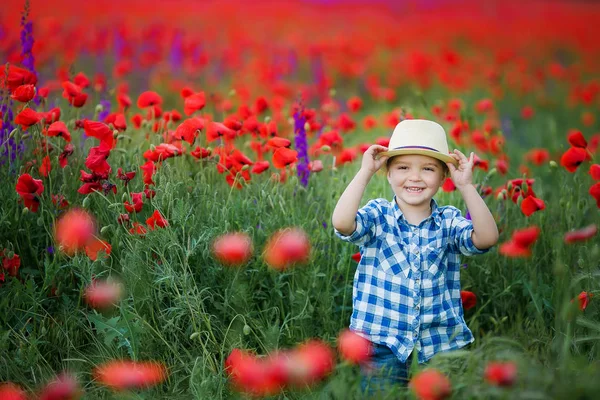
0, 0, 600, 400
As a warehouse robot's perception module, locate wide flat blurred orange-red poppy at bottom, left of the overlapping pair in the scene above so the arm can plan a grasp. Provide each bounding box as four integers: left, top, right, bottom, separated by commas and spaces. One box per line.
94, 360, 167, 390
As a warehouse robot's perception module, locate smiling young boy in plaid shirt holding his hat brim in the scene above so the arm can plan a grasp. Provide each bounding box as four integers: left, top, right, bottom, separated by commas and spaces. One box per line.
332, 120, 498, 393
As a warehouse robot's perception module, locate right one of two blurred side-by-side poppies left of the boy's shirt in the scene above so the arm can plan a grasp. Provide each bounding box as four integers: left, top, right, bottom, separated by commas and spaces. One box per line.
264, 228, 310, 270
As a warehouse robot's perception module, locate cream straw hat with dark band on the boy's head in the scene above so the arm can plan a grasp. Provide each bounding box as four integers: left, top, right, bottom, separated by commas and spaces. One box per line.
380, 119, 458, 165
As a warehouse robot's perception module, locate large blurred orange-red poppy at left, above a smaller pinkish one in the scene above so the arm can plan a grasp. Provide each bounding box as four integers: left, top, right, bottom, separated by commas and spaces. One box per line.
54, 208, 96, 256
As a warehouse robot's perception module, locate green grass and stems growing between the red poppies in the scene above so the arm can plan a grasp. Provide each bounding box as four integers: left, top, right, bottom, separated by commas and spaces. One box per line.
0, 79, 600, 399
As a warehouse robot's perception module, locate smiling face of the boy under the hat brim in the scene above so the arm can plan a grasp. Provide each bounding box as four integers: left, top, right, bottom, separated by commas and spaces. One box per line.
387, 154, 445, 208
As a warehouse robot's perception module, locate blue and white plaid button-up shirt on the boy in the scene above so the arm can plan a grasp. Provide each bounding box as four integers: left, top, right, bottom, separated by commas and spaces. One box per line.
334, 196, 488, 363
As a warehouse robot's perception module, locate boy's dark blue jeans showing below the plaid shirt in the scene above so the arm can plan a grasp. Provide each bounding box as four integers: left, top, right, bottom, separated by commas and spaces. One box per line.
360, 343, 420, 396
